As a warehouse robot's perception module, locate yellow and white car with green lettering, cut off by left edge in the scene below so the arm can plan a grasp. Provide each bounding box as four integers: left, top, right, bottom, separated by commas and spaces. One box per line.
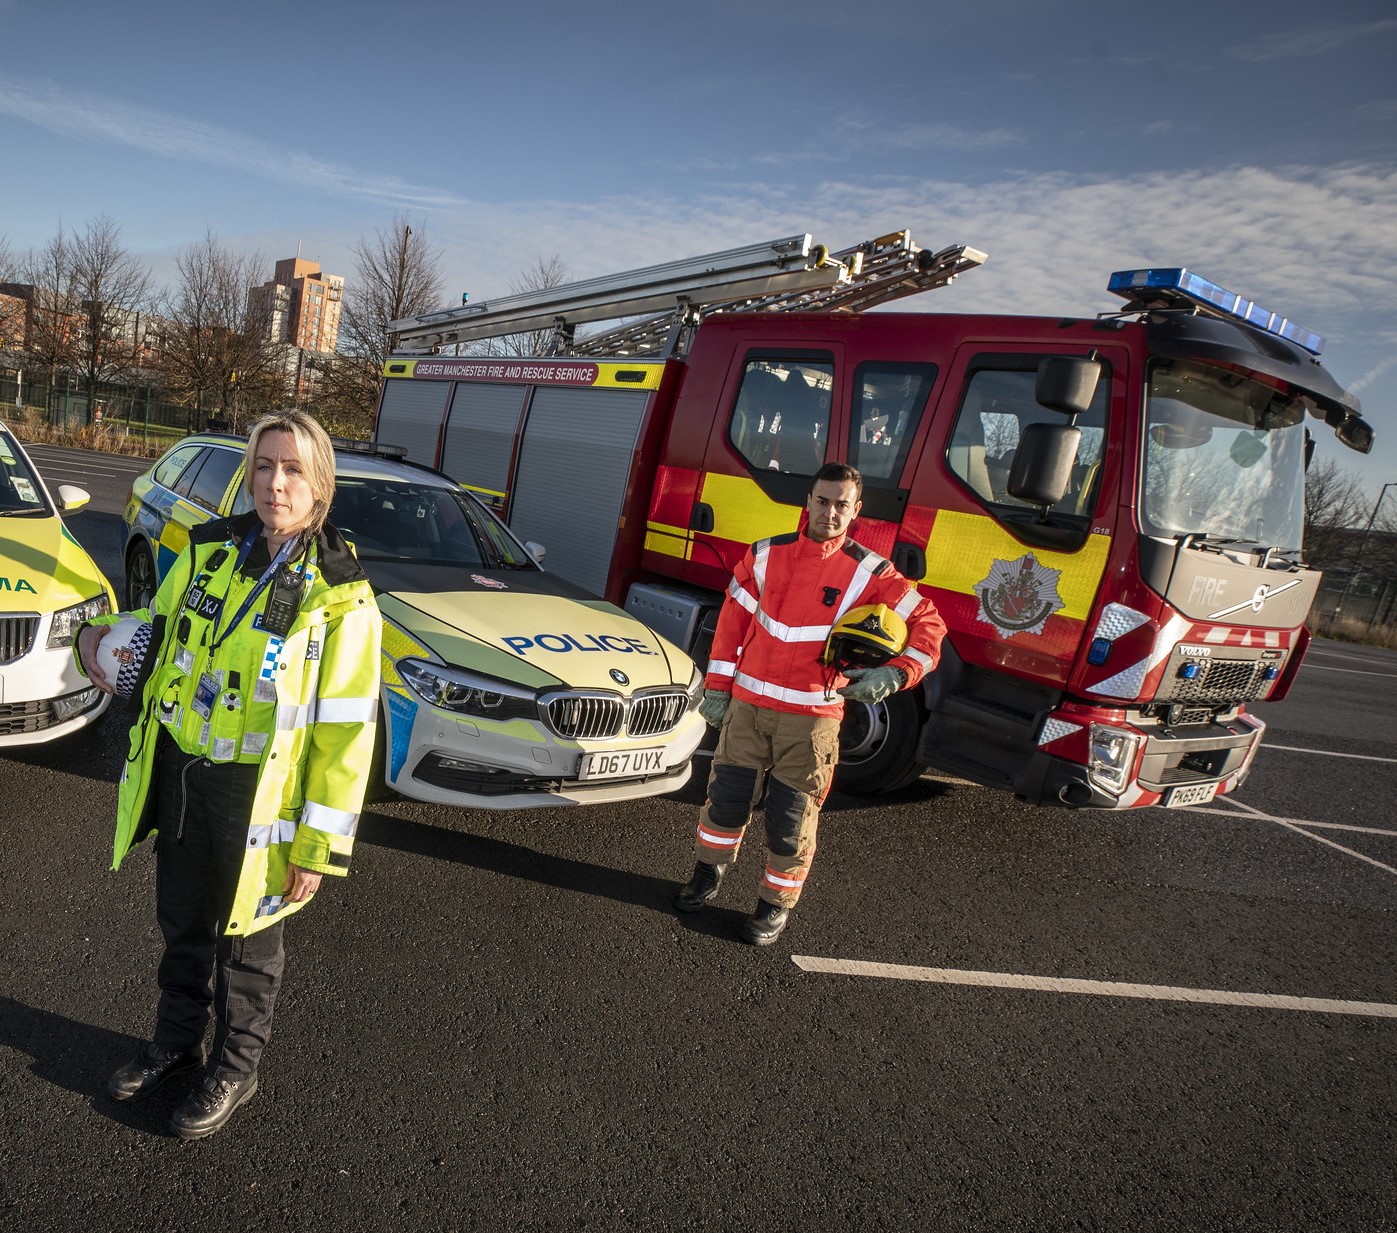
0, 423, 116, 747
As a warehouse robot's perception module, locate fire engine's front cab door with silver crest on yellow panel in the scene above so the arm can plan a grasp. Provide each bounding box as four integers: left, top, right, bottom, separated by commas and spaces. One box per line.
909, 341, 1129, 688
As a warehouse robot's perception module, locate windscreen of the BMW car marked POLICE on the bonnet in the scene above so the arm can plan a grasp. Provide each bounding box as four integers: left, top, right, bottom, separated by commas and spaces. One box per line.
330, 476, 538, 570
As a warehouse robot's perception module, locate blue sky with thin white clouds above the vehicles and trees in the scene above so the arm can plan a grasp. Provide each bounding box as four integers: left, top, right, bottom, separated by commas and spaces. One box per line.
0, 0, 1397, 494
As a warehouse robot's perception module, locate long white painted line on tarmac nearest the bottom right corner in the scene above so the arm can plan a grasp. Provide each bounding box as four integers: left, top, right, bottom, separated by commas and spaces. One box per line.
791, 955, 1397, 1019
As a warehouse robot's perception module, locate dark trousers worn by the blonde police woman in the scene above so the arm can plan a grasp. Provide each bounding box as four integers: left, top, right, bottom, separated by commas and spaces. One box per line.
155, 733, 285, 1079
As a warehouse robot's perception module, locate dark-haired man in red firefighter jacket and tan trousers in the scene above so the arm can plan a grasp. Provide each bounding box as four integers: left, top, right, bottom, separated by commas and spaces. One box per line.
675, 462, 946, 945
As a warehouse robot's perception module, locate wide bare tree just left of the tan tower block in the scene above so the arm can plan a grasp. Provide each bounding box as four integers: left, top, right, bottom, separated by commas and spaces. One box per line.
161, 232, 288, 430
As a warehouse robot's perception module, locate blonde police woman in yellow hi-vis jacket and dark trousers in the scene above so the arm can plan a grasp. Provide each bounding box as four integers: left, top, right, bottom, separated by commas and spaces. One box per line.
77, 411, 380, 1139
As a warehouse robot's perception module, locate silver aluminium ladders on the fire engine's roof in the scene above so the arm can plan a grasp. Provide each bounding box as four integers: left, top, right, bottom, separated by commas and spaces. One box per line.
388, 232, 985, 355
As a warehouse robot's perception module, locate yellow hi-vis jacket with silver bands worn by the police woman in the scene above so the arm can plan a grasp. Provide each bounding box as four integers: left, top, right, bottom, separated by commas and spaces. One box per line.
94, 512, 383, 934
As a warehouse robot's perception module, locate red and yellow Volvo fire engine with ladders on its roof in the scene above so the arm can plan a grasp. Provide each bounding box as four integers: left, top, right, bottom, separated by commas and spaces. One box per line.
376, 232, 1372, 809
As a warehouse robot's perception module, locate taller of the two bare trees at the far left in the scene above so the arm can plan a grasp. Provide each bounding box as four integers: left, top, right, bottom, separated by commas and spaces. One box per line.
68, 214, 151, 406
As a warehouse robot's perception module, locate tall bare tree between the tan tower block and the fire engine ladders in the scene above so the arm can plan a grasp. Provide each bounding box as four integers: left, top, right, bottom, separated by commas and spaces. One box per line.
312, 214, 443, 437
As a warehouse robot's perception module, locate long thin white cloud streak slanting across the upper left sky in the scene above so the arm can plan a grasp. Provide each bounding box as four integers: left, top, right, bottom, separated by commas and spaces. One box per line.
0, 74, 465, 209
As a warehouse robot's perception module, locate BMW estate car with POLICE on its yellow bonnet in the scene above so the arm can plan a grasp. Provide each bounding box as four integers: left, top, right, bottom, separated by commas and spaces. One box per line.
126, 433, 704, 809
